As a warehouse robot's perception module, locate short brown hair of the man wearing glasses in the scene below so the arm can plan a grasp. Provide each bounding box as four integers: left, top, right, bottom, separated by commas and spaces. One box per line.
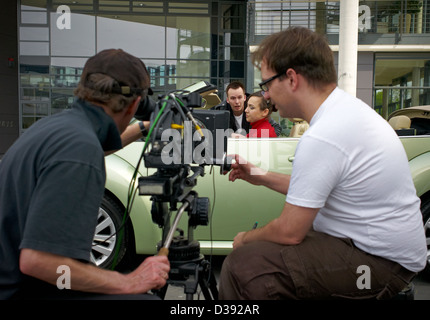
252, 27, 337, 88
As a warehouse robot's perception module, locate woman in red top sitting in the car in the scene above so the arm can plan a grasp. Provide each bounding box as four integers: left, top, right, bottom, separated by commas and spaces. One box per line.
245, 91, 277, 138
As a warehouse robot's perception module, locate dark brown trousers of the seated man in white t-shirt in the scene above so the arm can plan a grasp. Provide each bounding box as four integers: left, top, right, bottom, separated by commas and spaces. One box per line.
219, 231, 415, 300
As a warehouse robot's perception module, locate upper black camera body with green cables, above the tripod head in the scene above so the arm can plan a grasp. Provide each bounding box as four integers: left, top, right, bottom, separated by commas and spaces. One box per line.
144, 92, 230, 168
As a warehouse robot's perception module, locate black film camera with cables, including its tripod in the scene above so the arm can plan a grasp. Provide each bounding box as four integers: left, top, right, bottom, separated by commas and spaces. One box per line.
136, 81, 231, 300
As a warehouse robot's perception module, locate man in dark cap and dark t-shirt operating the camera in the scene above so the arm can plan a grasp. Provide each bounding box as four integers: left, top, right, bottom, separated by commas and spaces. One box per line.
0, 49, 170, 299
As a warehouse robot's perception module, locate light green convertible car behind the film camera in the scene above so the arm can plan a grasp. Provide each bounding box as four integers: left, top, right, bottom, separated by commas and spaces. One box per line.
92, 85, 430, 276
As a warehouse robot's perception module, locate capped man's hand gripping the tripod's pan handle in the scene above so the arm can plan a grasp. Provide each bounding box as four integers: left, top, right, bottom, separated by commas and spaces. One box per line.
122, 256, 170, 293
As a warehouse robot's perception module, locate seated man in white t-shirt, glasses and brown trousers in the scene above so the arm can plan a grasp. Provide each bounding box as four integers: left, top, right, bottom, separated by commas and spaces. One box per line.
220, 27, 427, 299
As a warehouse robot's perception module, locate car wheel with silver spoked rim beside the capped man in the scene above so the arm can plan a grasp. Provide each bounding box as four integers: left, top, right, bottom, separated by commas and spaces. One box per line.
91, 194, 133, 269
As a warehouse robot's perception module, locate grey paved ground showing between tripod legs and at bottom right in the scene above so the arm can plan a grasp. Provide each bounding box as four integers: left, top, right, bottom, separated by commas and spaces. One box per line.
156, 257, 430, 300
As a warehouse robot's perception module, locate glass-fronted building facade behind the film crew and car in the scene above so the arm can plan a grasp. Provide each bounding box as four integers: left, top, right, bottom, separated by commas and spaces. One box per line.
0, 0, 430, 156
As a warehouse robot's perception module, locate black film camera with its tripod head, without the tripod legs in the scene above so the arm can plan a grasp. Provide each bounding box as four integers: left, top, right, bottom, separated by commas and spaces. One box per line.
139, 83, 230, 234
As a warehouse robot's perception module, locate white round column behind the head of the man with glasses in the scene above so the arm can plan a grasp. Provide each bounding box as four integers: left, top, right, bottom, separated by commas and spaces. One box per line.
338, 0, 359, 96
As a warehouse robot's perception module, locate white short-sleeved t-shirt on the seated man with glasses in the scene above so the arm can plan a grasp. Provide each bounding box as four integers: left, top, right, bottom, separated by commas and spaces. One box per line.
286, 88, 427, 272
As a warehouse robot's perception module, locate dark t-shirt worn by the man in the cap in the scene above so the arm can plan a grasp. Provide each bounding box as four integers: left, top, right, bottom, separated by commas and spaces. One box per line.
0, 100, 121, 299
